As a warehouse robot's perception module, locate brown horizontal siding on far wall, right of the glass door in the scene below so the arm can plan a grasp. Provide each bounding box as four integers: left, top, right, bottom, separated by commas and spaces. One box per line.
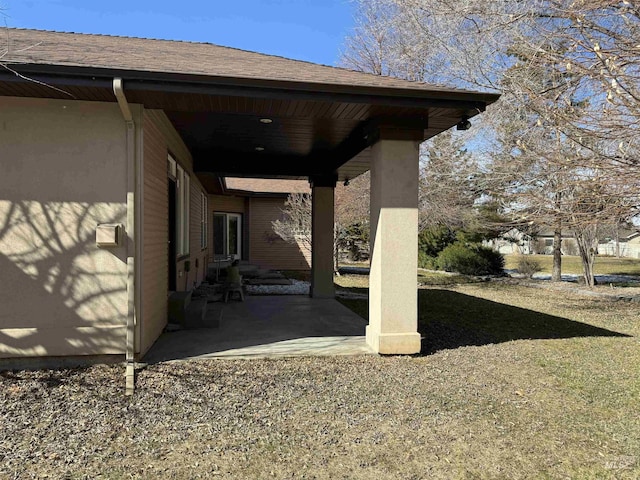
249, 198, 311, 270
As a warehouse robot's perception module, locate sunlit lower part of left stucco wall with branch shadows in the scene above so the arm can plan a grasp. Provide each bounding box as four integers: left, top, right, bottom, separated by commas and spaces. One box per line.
0, 200, 127, 358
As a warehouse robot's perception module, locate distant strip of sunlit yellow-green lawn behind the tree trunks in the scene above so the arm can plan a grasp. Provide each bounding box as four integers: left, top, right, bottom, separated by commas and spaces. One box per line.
504, 255, 640, 275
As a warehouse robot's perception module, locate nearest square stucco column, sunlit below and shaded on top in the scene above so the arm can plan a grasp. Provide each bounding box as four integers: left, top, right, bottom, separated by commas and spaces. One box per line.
366, 140, 420, 354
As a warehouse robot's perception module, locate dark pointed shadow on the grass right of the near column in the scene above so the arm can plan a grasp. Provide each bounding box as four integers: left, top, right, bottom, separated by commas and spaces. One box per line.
418, 289, 629, 355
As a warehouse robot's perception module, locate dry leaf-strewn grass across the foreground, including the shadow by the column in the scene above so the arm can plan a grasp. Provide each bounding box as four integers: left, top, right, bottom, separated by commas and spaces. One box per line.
0, 282, 640, 480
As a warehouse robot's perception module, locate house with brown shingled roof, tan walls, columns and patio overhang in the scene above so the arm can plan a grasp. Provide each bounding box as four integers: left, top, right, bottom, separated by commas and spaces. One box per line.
0, 28, 498, 378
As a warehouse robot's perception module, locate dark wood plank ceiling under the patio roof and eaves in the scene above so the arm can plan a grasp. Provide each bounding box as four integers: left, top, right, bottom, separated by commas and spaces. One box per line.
0, 81, 477, 183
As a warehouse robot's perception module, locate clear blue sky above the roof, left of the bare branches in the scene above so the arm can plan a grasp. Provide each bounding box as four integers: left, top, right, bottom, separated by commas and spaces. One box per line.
0, 0, 353, 65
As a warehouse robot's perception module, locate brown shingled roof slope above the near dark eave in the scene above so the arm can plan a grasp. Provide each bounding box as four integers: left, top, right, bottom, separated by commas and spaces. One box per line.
0, 28, 494, 98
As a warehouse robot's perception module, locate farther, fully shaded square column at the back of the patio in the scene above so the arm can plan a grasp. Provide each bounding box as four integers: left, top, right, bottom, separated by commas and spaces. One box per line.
309, 177, 336, 298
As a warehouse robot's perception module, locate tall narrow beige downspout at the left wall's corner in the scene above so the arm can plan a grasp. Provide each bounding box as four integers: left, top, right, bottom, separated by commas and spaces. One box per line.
113, 78, 142, 395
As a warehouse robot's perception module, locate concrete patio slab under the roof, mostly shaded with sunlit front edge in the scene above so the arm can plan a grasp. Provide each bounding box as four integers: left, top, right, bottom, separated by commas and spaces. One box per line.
143, 296, 374, 363
